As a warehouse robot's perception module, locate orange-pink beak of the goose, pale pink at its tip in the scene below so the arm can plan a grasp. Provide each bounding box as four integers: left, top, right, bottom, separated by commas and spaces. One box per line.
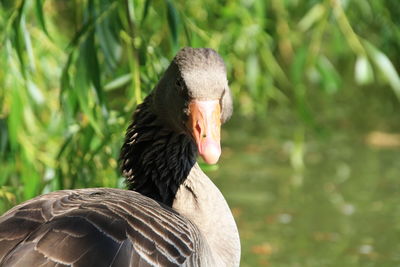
187, 100, 221, 164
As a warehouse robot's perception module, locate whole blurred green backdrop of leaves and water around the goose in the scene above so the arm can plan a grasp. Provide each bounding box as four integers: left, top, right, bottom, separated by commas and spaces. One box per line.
0, 0, 400, 266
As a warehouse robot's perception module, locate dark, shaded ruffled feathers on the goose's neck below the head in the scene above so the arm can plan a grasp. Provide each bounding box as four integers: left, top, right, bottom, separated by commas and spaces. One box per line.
120, 95, 197, 206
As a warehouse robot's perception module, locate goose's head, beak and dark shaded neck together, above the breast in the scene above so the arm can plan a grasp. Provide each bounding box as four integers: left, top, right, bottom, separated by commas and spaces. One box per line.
120, 48, 232, 205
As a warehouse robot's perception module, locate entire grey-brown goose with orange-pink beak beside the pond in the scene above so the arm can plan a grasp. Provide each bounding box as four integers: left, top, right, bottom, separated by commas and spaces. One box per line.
0, 48, 240, 267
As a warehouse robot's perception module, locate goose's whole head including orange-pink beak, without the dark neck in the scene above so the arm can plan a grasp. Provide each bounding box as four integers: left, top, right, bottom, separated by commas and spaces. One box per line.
154, 48, 232, 164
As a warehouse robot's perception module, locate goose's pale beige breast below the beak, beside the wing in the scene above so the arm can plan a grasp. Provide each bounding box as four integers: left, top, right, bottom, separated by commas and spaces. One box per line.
172, 163, 240, 266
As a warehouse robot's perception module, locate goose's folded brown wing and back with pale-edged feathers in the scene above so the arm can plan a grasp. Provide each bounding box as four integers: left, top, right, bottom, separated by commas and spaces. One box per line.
0, 188, 200, 267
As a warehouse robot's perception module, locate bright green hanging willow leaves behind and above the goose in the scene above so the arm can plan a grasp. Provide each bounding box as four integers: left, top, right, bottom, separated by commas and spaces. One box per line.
0, 0, 400, 213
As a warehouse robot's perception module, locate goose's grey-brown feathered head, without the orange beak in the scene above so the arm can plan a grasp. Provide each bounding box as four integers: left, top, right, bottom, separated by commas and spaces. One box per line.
154, 47, 232, 128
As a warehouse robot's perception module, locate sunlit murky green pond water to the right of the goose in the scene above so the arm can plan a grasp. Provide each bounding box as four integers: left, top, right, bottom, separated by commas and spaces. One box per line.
208, 120, 400, 267
